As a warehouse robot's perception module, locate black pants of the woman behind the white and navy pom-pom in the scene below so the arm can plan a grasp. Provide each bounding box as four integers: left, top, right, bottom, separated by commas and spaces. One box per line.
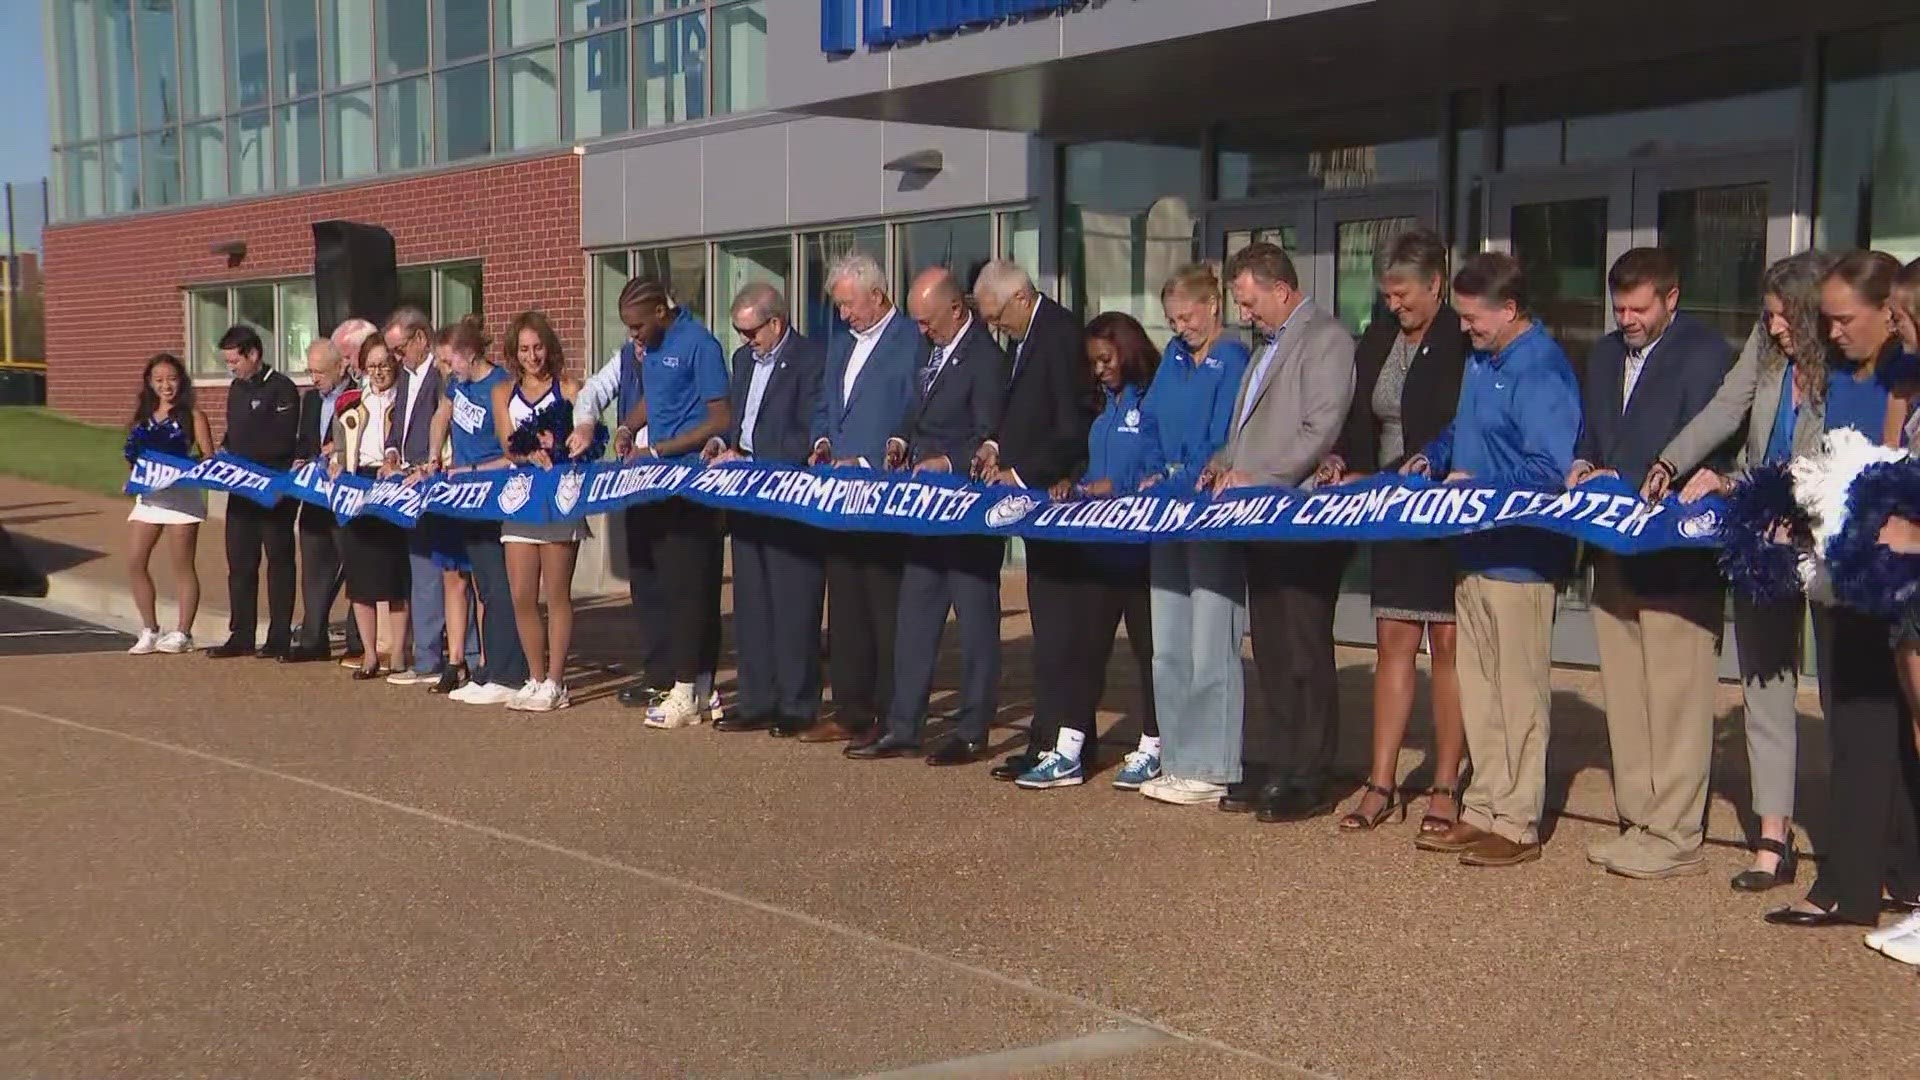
1807, 607, 1920, 924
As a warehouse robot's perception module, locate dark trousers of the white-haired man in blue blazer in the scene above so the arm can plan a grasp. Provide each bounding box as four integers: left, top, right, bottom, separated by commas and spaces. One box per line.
822, 532, 906, 730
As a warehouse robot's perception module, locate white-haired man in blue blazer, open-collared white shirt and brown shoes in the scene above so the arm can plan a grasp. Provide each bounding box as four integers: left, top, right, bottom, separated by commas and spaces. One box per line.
801, 250, 927, 746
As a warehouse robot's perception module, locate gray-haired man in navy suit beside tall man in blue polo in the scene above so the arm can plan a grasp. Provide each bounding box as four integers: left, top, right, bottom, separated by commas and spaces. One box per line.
701, 282, 826, 738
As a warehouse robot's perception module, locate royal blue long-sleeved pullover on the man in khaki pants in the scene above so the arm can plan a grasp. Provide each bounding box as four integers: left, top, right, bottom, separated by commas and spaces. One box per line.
1421, 323, 1580, 582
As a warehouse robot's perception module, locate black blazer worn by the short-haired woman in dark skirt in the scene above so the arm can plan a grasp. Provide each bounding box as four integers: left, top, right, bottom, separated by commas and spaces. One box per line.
1334, 304, 1473, 473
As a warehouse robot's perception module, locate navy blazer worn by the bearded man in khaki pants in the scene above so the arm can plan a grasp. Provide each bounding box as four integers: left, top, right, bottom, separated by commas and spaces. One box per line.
1572, 311, 1734, 596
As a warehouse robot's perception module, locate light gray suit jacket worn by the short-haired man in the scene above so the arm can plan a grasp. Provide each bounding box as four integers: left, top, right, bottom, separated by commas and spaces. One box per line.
1212, 300, 1354, 488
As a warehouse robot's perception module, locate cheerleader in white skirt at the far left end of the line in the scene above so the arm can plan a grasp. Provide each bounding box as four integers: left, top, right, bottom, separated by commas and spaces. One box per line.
127, 352, 213, 655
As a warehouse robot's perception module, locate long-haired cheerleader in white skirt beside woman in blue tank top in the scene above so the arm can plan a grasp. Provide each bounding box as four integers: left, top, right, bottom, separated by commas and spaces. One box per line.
493, 311, 597, 713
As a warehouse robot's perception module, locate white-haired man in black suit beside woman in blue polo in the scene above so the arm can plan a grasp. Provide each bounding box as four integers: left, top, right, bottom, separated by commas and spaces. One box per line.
973, 259, 1100, 788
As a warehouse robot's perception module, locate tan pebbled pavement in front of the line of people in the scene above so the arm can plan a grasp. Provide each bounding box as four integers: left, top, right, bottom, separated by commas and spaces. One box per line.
0, 474, 1920, 1078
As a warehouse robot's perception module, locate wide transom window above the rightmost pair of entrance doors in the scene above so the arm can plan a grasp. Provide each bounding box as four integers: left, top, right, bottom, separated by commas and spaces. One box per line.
1501, 42, 1801, 169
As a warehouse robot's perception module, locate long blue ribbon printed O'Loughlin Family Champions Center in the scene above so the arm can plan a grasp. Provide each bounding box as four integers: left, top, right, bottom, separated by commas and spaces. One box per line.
127, 454, 1726, 555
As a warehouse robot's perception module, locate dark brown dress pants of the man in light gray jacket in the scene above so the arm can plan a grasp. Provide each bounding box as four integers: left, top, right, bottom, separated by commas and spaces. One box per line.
1240, 544, 1352, 786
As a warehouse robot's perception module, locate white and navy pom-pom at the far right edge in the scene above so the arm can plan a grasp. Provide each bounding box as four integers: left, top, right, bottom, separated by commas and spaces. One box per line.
1789, 429, 1920, 617
